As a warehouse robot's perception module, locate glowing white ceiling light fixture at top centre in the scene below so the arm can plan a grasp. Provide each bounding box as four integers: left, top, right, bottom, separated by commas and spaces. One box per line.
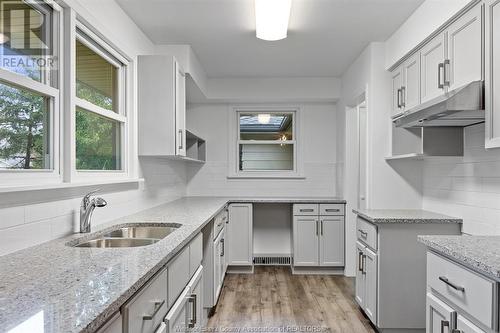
255, 0, 292, 41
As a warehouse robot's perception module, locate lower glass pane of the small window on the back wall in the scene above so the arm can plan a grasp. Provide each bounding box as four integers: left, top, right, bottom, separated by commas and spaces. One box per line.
239, 144, 293, 171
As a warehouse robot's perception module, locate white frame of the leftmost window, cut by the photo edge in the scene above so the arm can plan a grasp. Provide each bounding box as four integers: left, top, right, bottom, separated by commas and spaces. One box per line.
0, 0, 63, 186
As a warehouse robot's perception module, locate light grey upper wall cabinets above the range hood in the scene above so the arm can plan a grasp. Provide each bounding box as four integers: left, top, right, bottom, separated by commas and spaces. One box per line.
392, 4, 483, 112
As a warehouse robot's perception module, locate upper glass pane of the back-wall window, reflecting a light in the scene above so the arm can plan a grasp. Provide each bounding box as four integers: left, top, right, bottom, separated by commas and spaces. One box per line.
239, 113, 293, 141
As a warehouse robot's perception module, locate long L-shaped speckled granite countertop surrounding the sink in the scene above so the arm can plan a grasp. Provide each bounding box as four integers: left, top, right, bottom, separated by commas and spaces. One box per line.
0, 197, 345, 333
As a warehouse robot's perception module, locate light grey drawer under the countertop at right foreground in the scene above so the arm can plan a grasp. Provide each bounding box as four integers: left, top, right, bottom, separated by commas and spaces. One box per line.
427, 252, 496, 328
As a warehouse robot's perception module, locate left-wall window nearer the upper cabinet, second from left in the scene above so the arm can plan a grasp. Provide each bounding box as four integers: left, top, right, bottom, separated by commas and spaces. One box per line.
75, 30, 127, 171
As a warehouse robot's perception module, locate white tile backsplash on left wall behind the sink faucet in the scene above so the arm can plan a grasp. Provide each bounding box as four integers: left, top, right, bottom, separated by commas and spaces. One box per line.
0, 158, 187, 255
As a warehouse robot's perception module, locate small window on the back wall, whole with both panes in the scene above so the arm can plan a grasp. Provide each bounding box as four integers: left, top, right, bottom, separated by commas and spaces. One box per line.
230, 108, 299, 178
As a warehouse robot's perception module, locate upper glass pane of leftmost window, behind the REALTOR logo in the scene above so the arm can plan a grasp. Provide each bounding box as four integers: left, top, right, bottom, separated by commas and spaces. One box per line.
0, 0, 52, 82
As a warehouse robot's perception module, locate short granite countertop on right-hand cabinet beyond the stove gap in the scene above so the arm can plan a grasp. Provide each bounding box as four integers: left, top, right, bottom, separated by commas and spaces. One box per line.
352, 209, 462, 224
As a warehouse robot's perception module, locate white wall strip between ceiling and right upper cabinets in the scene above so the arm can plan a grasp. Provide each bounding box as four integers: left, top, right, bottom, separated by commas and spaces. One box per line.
385, 0, 471, 68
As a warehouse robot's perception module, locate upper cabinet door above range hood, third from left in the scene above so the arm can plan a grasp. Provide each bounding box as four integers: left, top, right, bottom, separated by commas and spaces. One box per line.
420, 34, 446, 103
